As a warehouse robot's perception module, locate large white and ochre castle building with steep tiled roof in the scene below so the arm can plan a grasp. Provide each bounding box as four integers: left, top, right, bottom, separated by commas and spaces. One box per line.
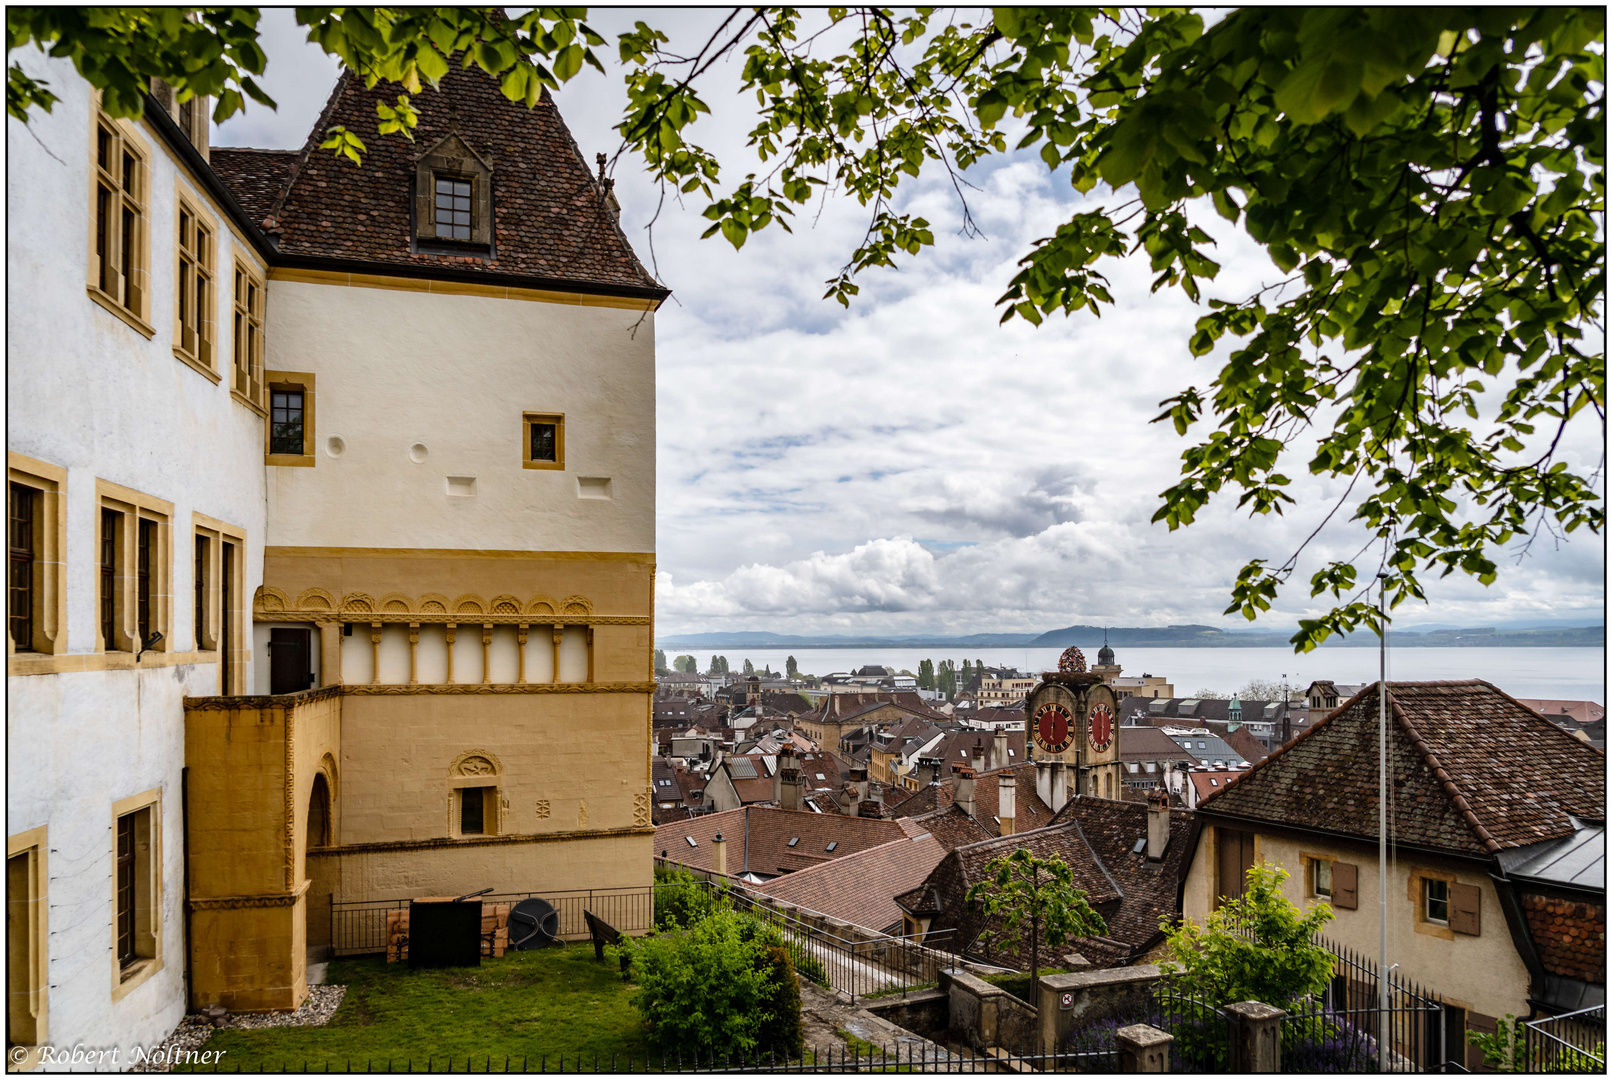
6, 46, 669, 1044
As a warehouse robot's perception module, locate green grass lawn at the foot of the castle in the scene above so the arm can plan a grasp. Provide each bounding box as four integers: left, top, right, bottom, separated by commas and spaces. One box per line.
191, 941, 650, 1072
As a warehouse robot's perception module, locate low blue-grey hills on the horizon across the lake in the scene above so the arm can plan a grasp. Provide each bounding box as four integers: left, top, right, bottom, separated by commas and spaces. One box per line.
656, 624, 1607, 650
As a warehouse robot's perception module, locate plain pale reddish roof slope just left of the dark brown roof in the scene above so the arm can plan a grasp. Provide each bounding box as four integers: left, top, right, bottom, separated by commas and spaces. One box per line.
754, 835, 946, 932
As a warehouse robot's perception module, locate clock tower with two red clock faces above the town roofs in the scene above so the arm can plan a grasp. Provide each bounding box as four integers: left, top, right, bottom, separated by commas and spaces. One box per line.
1025, 648, 1120, 799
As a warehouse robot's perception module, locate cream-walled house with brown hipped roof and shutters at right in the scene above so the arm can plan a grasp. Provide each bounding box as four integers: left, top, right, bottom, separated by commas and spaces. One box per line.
1185, 680, 1606, 1057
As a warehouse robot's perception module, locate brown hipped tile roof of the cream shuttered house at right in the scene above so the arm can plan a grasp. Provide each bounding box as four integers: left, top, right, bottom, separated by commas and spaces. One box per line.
1203, 680, 1606, 854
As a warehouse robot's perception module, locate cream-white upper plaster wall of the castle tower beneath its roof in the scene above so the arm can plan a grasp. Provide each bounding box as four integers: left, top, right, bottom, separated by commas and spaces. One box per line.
268, 280, 654, 554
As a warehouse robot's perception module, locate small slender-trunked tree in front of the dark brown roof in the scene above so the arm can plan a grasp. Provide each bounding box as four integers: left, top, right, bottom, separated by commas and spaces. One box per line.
966, 848, 1107, 993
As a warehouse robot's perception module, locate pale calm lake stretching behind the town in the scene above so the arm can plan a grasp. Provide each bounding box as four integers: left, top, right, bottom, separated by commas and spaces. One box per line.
667, 648, 1606, 703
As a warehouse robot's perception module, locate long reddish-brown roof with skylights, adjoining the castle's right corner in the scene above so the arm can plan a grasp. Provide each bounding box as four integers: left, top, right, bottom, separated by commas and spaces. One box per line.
654, 806, 906, 877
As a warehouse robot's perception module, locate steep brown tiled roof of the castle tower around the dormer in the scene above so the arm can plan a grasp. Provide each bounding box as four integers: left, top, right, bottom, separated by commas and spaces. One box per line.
211, 63, 666, 297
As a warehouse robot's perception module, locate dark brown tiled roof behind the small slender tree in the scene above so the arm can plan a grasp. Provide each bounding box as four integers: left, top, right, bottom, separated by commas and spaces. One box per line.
896, 795, 1196, 970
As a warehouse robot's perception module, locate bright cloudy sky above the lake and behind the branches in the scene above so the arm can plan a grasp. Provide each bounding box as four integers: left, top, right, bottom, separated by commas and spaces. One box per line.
214, 10, 1606, 635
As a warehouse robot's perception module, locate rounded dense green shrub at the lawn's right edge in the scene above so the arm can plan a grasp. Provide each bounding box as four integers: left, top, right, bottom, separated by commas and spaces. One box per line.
630, 906, 776, 1059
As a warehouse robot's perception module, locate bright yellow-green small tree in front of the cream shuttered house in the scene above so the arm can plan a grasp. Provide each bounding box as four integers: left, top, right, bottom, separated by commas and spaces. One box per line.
1159, 862, 1333, 1009
